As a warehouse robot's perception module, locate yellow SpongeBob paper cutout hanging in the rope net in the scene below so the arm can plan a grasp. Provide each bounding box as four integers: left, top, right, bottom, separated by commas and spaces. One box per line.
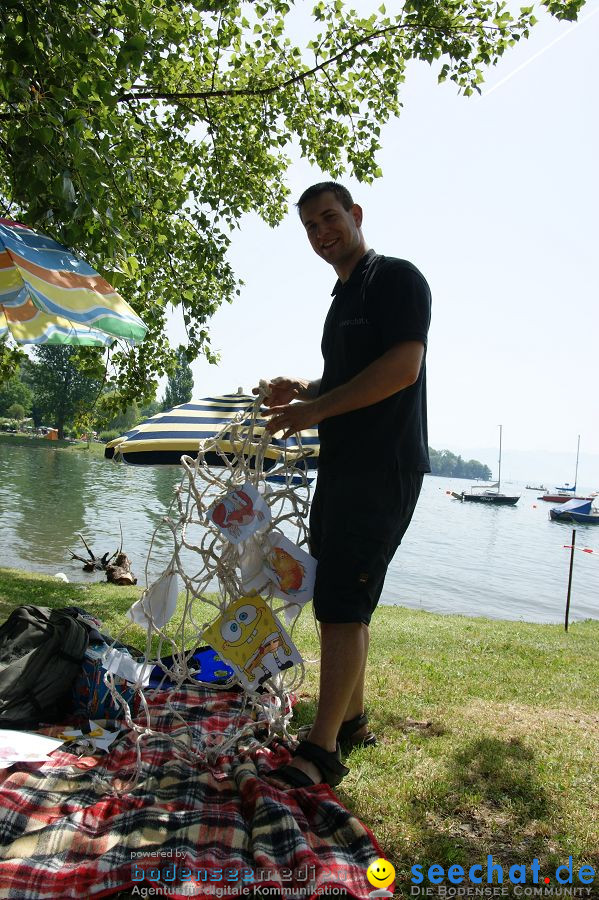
204, 596, 302, 690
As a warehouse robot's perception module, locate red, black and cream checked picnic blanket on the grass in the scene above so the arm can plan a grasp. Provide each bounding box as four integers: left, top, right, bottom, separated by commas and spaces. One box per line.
0, 686, 382, 900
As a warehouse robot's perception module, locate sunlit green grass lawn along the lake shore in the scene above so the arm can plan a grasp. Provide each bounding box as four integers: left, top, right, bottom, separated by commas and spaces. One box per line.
0, 569, 599, 898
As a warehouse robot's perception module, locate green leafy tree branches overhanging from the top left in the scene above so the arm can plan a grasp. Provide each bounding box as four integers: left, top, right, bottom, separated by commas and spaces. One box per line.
0, 0, 584, 403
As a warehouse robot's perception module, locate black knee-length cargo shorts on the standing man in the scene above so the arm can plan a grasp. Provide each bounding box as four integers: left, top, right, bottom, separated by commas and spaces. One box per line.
310, 464, 423, 625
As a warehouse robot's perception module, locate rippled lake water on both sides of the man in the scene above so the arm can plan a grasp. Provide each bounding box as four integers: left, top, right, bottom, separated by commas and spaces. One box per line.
0, 444, 599, 622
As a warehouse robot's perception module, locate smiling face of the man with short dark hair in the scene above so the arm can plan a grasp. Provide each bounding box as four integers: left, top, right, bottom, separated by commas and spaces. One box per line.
300, 191, 362, 268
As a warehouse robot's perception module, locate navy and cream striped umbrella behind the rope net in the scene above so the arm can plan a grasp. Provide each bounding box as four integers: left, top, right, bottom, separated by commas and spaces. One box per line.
104, 393, 319, 469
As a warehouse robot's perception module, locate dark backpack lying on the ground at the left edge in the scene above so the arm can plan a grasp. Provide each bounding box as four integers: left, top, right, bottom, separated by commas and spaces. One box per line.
0, 606, 89, 728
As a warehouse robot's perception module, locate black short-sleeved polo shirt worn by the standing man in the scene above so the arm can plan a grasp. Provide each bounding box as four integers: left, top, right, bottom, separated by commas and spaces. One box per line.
318, 250, 431, 472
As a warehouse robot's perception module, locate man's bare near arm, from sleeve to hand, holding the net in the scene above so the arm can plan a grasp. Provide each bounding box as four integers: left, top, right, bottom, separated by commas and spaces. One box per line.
267, 341, 424, 437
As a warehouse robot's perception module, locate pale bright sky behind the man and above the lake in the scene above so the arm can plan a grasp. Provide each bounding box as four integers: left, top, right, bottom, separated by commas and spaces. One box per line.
169, 0, 599, 489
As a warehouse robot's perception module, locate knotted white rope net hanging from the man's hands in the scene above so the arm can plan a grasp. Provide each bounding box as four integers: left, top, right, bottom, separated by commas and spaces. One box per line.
104, 392, 310, 790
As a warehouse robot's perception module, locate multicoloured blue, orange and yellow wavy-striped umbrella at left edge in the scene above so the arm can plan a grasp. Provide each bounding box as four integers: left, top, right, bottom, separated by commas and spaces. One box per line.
0, 219, 147, 347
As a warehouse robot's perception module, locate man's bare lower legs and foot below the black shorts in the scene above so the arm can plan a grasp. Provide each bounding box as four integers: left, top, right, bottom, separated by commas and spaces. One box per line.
282, 622, 368, 782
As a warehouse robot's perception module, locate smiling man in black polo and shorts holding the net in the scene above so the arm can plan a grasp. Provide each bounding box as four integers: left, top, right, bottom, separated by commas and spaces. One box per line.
266, 182, 431, 787
